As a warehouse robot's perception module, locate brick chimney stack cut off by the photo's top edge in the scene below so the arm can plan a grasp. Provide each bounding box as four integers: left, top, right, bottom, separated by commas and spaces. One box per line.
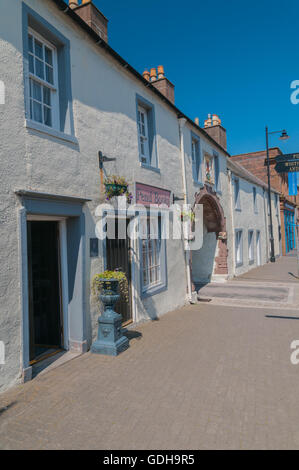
69, 0, 108, 42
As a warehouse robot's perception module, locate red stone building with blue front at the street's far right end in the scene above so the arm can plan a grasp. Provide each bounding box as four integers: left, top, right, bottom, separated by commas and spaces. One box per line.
231, 147, 299, 255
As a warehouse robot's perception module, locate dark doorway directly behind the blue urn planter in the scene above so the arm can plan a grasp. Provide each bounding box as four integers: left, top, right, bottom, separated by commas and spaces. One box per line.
106, 219, 132, 323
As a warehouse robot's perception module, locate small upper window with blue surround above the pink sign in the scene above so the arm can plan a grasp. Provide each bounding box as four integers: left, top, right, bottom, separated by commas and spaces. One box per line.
136, 94, 159, 171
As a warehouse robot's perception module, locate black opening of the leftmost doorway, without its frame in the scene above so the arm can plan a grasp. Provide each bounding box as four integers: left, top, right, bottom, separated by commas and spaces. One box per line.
27, 221, 62, 361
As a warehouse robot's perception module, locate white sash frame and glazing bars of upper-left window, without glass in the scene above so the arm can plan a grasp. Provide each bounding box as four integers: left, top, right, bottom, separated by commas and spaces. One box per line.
27, 28, 60, 131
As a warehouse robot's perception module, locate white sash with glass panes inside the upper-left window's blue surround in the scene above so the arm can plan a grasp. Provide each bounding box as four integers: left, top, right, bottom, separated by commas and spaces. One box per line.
28, 31, 59, 128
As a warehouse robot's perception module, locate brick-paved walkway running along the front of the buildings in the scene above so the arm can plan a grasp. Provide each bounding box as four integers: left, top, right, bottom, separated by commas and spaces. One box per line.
0, 258, 299, 449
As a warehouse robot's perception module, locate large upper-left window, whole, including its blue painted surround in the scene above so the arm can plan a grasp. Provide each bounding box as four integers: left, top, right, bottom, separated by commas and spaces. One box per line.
21, 2, 78, 141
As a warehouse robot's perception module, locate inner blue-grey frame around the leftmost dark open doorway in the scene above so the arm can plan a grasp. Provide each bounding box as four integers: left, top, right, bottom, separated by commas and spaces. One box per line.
26, 214, 69, 351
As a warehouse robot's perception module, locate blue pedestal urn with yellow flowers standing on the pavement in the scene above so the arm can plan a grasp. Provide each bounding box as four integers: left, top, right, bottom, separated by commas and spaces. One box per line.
91, 271, 129, 356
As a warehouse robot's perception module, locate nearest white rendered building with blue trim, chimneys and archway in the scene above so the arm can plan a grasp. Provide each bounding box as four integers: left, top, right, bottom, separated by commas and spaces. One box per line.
0, 0, 282, 391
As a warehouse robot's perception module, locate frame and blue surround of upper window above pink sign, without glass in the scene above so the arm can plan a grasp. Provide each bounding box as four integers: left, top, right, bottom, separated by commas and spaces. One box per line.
136, 93, 160, 173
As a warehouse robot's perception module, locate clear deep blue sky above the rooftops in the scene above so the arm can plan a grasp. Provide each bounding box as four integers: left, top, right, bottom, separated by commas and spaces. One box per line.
94, 0, 299, 154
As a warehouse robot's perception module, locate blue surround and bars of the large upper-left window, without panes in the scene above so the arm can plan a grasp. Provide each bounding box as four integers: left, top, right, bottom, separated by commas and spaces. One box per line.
22, 3, 77, 143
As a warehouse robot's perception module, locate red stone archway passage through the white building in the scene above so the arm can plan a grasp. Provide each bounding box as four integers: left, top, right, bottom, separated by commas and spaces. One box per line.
192, 185, 228, 284
